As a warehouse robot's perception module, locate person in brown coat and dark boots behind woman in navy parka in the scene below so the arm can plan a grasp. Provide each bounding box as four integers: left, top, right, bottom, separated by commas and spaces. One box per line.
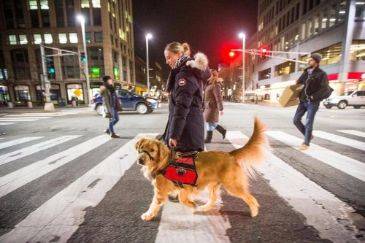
204, 70, 227, 143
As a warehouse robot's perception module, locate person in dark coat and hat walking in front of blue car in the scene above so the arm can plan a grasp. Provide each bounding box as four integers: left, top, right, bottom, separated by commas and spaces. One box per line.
100, 76, 122, 138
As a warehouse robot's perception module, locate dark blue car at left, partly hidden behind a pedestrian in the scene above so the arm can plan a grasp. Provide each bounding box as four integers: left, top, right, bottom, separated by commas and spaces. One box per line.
93, 89, 159, 115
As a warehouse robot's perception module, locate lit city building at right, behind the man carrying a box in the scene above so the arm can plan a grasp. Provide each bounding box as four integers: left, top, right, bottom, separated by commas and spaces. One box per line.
246, 0, 365, 101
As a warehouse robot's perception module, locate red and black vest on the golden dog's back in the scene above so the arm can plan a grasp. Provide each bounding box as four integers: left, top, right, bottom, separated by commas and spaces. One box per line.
162, 156, 198, 187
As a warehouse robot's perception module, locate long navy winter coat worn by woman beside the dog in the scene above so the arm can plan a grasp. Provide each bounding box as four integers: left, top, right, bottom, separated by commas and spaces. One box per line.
164, 58, 207, 152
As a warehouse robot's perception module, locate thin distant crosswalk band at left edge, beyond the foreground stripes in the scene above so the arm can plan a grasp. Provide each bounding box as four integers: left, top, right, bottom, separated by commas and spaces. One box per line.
0, 108, 90, 126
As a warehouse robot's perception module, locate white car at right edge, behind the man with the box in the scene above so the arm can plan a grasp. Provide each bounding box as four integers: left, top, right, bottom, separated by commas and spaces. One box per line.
323, 90, 365, 109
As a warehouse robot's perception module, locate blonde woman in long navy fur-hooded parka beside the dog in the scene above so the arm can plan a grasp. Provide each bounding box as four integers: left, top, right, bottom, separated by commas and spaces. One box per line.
163, 42, 208, 152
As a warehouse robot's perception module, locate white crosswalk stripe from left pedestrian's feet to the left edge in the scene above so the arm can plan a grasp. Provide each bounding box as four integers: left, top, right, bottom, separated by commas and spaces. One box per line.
0, 135, 110, 197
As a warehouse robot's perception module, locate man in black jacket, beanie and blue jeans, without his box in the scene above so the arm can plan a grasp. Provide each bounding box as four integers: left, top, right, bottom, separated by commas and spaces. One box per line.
293, 53, 330, 150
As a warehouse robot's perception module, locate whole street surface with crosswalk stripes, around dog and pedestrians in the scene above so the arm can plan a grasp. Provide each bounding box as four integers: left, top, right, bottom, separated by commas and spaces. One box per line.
0, 103, 365, 243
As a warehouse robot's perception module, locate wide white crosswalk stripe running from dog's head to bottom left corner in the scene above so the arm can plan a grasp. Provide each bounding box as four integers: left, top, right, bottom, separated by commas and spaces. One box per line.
0, 134, 157, 242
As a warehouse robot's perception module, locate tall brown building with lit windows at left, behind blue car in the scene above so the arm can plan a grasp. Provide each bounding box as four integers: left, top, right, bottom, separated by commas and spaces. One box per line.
0, 0, 135, 105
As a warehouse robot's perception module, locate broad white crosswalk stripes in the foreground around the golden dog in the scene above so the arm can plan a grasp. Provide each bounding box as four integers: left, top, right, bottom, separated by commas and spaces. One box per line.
0, 130, 365, 242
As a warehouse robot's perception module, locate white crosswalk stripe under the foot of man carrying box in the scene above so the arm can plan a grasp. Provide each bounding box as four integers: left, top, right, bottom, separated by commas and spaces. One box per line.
266, 131, 365, 181
